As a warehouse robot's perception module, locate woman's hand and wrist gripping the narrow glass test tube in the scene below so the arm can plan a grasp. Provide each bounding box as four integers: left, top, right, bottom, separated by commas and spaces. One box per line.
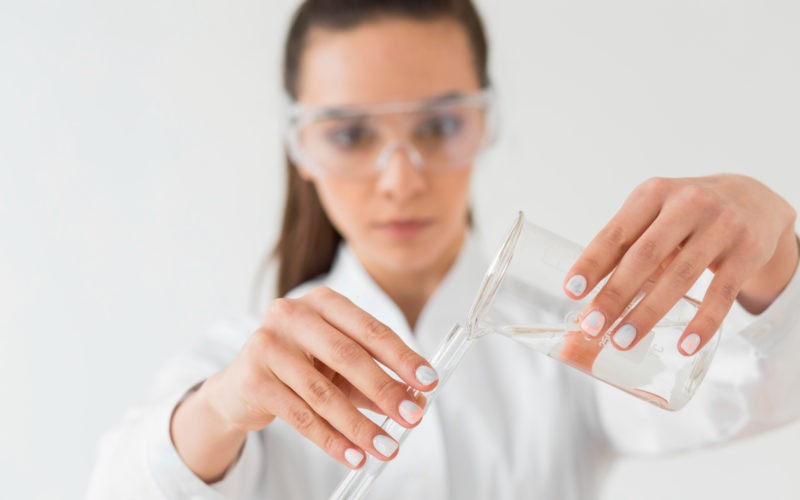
172, 287, 437, 482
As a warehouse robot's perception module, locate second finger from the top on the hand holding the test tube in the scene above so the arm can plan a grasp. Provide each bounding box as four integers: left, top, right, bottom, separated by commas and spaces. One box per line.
282, 308, 422, 427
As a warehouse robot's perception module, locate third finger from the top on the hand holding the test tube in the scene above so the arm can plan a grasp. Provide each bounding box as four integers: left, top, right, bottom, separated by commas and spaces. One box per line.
271, 353, 398, 460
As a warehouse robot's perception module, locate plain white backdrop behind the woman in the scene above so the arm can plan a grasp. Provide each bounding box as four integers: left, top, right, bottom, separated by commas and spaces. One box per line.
0, 0, 800, 500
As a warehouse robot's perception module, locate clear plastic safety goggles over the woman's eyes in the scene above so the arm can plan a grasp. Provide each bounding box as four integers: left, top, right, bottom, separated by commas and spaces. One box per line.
290, 93, 489, 178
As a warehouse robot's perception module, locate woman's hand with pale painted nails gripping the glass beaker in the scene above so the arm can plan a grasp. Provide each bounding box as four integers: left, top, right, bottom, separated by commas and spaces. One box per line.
564, 175, 798, 356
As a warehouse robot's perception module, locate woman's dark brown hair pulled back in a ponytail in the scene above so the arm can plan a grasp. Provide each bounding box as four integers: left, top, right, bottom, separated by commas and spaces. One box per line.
272, 0, 489, 297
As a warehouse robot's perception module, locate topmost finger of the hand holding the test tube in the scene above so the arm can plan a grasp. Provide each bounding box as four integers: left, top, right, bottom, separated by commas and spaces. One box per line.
304, 287, 438, 391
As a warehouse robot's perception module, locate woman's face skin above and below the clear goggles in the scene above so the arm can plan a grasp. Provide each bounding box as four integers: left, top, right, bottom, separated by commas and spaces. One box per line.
298, 18, 480, 272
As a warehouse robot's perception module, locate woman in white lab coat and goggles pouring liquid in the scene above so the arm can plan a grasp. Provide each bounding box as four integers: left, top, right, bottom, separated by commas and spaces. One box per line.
90, 0, 800, 499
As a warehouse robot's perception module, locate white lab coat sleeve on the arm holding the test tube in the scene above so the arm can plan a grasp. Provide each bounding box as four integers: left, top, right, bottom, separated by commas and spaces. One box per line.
87, 323, 263, 500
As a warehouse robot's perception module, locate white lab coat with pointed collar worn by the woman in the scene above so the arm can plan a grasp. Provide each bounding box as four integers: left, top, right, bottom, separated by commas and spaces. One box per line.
88, 238, 800, 500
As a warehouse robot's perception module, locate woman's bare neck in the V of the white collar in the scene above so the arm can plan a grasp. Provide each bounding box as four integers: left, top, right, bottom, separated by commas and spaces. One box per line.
365, 233, 466, 331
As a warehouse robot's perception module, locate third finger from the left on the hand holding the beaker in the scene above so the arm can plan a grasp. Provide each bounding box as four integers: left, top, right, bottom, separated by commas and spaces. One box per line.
611, 233, 721, 350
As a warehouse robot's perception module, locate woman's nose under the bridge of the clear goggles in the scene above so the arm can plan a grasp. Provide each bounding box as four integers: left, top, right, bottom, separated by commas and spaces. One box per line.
376, 142, 427, 201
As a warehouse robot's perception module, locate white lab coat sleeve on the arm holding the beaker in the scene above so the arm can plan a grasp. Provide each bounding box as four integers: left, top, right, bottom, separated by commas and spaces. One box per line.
597, 254, 800, 455
